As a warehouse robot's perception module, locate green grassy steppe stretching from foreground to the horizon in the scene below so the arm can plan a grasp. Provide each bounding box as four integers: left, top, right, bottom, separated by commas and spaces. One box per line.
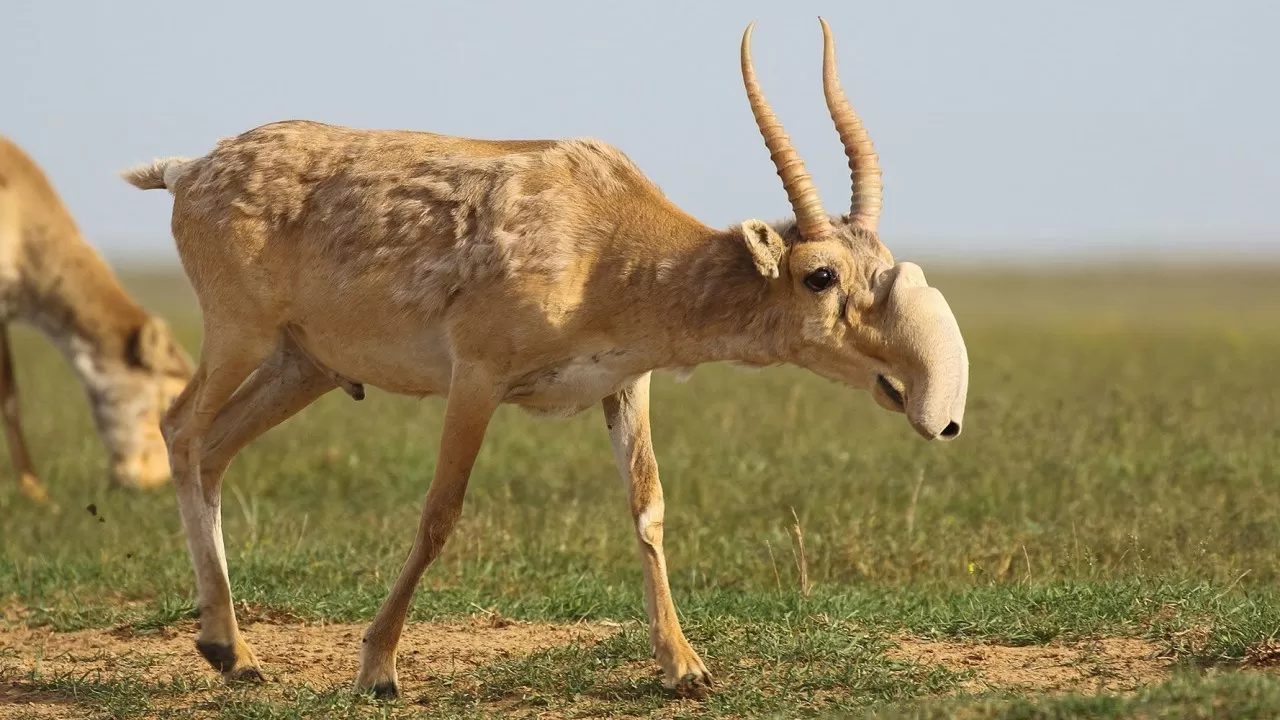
0, 268, 1280, 717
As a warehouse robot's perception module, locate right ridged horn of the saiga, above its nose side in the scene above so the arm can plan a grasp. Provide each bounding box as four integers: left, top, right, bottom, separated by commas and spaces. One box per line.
818, 18, 884, 231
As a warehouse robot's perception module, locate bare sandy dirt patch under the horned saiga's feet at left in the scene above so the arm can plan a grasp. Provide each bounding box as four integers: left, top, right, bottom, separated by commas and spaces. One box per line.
0, 616, 620, 720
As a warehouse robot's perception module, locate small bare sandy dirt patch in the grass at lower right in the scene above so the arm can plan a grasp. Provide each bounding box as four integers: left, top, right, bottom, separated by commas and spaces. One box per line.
890, 638, 1170, 693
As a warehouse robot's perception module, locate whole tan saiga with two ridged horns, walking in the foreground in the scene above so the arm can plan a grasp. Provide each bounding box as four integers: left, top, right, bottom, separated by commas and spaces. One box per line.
123, 22, 968, 696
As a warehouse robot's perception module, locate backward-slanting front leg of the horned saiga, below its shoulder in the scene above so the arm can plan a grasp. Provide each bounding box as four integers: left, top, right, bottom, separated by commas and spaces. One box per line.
356, 358, 500, 697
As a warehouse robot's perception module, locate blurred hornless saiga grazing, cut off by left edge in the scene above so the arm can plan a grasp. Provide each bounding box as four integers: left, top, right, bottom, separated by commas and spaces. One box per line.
0, 137, 192, 502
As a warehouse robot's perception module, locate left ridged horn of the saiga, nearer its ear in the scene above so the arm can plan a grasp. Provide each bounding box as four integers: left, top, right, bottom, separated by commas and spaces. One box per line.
742, 20, 831, 240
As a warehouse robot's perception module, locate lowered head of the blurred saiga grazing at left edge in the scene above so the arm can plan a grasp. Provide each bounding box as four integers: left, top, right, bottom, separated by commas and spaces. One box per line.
91, 316, 192, 488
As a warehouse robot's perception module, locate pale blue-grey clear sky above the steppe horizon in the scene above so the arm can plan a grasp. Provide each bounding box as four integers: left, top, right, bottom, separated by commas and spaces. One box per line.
0, 0, 1280, 261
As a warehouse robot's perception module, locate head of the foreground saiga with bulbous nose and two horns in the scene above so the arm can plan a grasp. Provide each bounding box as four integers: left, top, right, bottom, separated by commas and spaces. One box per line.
741, 18, 969, 439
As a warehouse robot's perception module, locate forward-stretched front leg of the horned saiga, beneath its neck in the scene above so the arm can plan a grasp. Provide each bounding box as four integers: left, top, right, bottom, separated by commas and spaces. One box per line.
604, 373, 712, 692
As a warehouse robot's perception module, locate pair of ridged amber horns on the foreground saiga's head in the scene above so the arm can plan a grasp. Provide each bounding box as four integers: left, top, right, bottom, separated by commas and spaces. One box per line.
742, 18, 882, 240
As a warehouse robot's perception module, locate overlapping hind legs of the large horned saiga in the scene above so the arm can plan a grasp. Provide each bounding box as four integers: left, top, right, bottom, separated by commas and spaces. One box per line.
164, 334, 335, 682
